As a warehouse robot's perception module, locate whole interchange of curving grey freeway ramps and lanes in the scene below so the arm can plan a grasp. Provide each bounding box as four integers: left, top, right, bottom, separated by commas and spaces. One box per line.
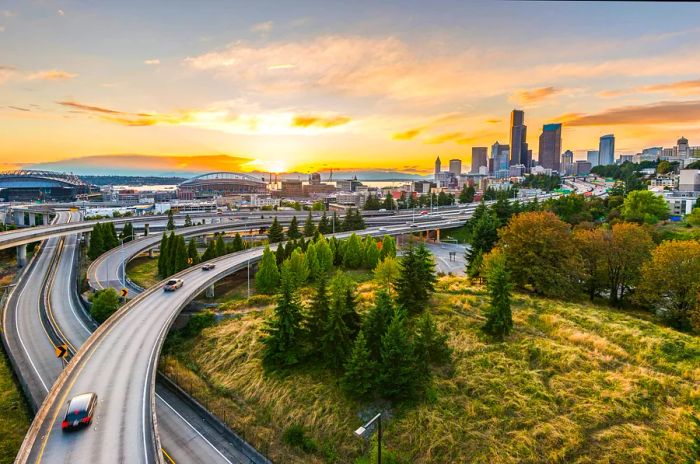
0, 195, 568, 463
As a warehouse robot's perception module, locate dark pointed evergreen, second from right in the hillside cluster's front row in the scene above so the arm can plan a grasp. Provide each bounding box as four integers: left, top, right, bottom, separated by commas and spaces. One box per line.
380, 310, 424, 399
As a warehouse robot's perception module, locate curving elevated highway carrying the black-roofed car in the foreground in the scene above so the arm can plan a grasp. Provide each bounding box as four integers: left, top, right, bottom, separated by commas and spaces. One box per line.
18, 221, 463, 463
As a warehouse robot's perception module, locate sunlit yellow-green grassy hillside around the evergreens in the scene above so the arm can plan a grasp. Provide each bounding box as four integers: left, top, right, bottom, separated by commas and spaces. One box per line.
164, 277, 700, 463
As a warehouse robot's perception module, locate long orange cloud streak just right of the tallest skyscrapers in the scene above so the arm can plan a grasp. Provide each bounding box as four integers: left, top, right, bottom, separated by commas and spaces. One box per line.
558, 100, 700, 126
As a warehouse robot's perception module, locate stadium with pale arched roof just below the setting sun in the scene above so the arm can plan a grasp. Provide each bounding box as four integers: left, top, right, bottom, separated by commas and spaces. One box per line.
177, 172, 267, 200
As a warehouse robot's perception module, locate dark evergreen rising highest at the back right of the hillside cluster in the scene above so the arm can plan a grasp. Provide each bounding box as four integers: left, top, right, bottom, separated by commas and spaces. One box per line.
396, 243, 437, 314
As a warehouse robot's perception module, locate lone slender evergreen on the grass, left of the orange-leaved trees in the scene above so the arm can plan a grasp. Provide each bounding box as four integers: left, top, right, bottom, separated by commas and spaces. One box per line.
484, 250, 513, 340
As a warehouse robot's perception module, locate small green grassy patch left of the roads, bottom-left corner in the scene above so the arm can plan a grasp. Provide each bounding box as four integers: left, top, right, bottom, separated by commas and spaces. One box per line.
0, 345, 31, 464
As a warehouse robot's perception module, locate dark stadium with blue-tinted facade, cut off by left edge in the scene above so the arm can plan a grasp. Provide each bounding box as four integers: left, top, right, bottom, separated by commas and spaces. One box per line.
0, 170, 90, 201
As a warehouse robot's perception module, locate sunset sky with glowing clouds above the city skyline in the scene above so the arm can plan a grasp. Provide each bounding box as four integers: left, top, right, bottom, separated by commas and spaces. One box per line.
0, 0, 700, 173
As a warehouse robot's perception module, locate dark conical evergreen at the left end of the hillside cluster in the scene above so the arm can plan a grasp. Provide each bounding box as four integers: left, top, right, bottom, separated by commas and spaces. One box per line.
256, 264, 304, 370
